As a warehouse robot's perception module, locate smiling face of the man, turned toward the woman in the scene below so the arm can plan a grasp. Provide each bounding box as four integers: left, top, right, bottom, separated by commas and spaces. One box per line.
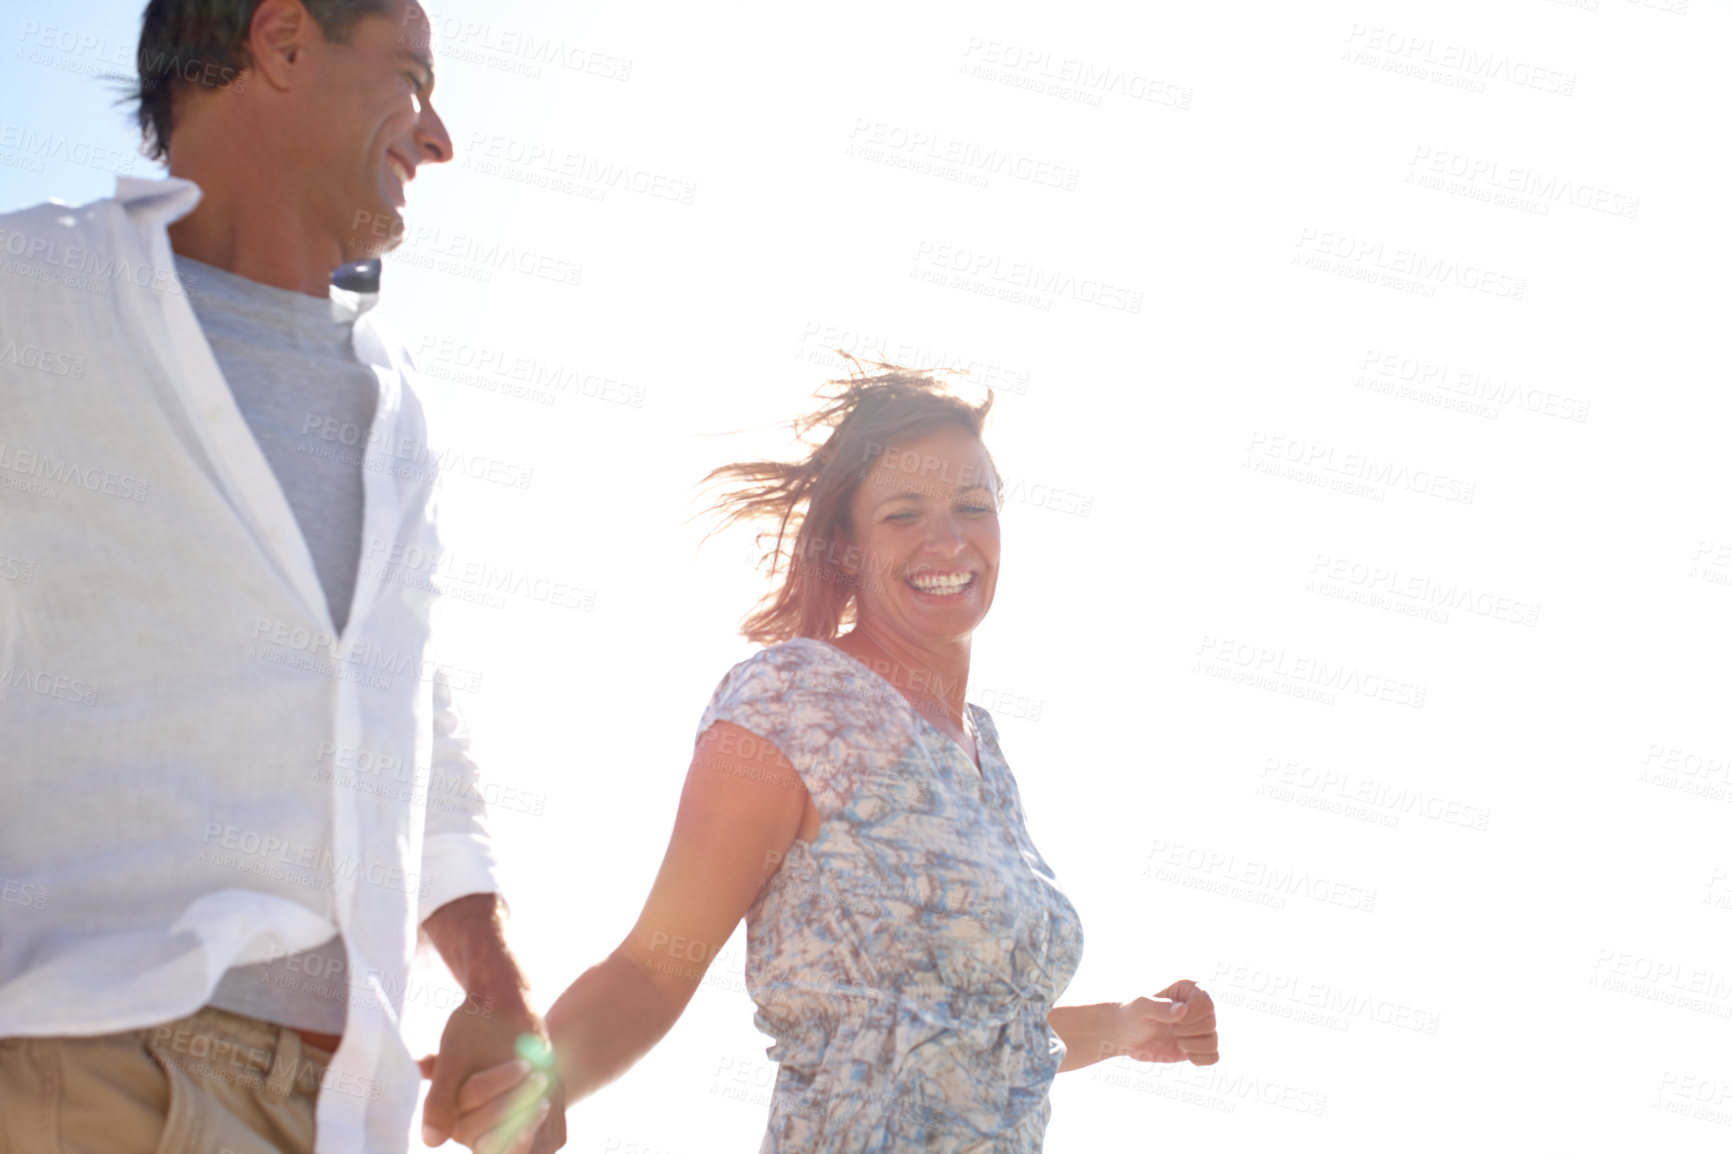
296, 0, 452, 260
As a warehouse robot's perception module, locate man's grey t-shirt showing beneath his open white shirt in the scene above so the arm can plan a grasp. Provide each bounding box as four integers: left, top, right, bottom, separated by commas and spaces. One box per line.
175, 256, 379, 1034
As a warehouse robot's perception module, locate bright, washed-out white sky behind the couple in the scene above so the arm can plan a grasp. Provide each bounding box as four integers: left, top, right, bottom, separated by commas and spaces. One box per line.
0, 0, 1732, 1154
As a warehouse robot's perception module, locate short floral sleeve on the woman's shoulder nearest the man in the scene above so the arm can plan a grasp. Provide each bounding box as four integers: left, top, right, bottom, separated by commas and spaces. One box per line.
698, 643, 854, 818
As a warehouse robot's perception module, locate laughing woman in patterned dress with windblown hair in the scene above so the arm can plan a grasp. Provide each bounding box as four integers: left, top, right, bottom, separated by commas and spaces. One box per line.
439, 367, 1218, 1154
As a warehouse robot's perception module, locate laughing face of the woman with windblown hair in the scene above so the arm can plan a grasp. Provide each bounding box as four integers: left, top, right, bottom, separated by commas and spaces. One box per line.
845, 425, 999, 645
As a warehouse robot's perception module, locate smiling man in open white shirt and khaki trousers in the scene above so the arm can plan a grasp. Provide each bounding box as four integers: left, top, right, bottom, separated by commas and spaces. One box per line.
0, 0, 565, 1154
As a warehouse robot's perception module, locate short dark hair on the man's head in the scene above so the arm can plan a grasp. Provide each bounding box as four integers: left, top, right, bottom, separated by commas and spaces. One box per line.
128, 0, 390, 159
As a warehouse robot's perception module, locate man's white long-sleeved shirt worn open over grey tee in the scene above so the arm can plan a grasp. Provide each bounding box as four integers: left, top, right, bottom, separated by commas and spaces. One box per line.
0, 177, 497, 1154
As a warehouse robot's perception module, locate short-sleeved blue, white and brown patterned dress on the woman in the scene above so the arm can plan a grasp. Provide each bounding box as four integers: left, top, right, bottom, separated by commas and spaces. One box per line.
698, 638, 1083, 1154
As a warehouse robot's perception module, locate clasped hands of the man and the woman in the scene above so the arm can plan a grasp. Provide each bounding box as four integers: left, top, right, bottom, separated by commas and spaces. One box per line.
421, 1002, 565, 1154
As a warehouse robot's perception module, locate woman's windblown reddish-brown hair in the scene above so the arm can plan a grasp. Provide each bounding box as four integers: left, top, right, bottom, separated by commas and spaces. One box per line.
703, 357, 1003, 645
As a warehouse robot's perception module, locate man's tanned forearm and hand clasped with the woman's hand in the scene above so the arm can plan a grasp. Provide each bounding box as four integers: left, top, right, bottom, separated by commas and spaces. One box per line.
421, 894, 565, 1154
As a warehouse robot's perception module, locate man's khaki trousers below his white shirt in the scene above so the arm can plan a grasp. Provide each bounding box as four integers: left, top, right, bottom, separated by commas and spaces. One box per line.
0, 1007, 331, 1154
